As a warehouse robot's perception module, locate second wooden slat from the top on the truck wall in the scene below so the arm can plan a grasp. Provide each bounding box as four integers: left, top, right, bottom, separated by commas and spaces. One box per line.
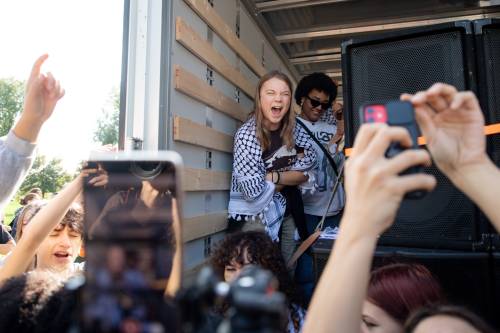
175, 17, 256, 98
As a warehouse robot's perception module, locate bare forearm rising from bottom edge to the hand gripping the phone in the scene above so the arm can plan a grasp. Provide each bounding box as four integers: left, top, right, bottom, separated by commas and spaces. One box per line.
304, 219, 377, 333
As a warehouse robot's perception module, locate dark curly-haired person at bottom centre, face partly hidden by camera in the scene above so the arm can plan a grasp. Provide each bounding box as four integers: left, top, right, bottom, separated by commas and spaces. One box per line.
210, 231, 305, 333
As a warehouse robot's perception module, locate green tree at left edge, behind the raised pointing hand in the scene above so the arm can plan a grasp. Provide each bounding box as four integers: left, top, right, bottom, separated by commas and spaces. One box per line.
0, 79, 24, 136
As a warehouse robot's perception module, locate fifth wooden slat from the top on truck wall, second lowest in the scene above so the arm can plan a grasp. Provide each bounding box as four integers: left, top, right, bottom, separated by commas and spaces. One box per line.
182, 168, 231, 192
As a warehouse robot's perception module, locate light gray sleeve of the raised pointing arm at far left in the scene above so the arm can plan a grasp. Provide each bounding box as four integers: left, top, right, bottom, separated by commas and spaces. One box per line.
0, 131, 36, 212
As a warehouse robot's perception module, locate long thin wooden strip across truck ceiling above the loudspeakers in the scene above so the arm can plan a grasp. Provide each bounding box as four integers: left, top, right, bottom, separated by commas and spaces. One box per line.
276, 14, 491, 43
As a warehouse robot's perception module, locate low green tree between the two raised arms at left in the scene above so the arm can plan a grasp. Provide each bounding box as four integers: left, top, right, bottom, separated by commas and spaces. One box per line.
20, 155, 73, 195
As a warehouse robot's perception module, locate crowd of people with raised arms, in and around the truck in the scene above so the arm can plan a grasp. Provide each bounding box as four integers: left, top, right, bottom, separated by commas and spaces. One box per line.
0, 55, 500, 333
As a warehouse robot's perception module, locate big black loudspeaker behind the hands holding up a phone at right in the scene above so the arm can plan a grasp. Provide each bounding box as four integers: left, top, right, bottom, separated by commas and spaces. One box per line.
342, 21, 483, 250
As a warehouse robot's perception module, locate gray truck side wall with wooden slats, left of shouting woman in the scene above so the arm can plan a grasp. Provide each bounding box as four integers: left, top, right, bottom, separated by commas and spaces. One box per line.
170, 0, 294, 249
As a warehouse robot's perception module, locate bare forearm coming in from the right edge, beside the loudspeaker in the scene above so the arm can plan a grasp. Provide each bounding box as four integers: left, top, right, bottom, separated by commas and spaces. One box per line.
450, 158, 500, 231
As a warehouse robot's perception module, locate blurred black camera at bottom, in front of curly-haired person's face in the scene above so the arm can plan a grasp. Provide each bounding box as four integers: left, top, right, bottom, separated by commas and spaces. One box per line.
177, 265, 287, 333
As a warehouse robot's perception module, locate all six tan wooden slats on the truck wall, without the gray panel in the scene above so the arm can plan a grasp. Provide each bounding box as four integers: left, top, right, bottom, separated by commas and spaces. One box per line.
172, 0, 266, 242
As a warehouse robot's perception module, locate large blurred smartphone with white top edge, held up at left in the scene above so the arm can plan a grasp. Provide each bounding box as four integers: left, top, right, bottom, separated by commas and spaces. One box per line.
79, 151, 182, 332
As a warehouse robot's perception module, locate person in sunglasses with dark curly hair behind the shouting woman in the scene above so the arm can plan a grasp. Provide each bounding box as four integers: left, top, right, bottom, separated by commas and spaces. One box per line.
294, 73, 345, 302
